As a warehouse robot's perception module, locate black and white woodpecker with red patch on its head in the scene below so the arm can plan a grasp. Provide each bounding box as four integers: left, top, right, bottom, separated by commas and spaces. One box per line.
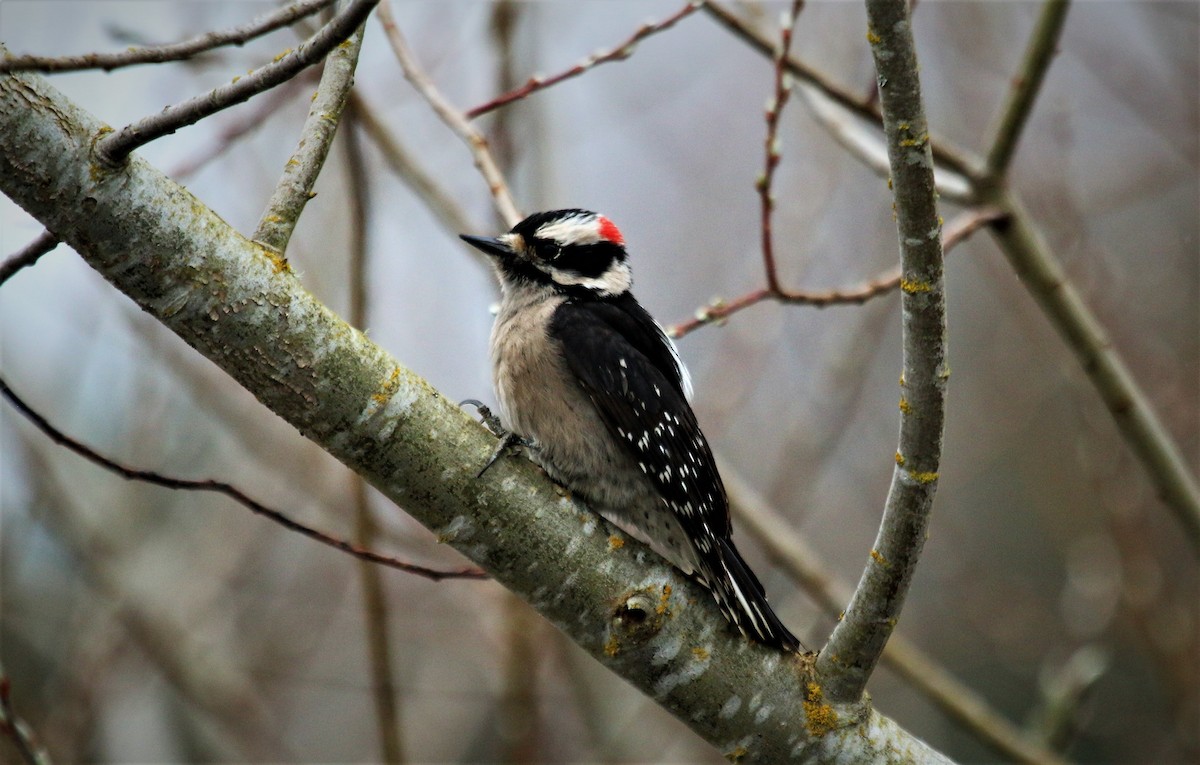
461, 209, 800, 652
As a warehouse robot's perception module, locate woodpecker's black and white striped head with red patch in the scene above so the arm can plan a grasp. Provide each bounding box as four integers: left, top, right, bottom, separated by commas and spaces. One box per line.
461, 210, 632, 297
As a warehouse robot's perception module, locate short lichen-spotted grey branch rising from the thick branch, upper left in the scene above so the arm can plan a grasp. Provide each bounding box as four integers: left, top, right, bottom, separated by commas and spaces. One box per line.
251, 16, 364, 254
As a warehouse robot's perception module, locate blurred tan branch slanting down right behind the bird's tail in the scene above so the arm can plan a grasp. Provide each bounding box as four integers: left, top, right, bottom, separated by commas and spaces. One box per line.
720, 460, 1062, 765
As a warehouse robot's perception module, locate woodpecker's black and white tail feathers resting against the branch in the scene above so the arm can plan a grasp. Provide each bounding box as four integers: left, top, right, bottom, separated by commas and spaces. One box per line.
702, 540, 802, 651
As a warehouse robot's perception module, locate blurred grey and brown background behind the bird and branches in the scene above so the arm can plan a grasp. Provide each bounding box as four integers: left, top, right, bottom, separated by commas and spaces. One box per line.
0, 0, 1200, 763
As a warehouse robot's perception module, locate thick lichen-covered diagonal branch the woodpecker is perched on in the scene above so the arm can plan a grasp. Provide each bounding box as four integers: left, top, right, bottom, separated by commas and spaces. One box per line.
0, 62, 944, 763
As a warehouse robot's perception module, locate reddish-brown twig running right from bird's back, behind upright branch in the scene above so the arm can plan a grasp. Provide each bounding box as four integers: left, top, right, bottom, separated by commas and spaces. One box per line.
667, 206, 1007, 338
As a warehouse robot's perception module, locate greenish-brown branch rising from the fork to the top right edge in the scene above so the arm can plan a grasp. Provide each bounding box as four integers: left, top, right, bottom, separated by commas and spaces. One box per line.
985, 0, 1070, 182
